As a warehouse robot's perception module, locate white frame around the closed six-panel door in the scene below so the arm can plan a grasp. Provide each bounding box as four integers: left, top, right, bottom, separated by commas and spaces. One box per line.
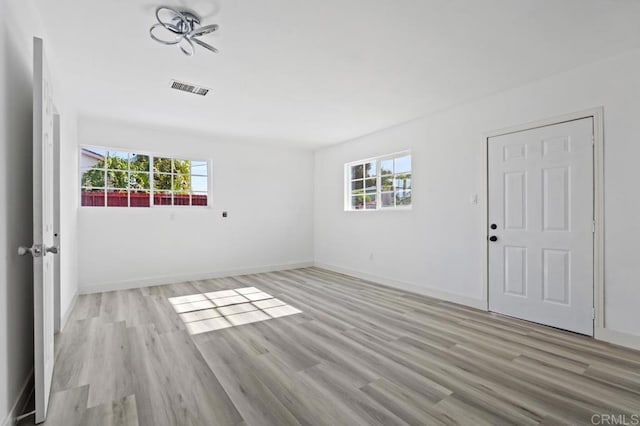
482, 107, 605, 332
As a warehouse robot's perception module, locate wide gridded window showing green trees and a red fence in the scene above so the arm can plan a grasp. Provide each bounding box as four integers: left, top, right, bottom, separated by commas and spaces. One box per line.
80, 147, 209, 207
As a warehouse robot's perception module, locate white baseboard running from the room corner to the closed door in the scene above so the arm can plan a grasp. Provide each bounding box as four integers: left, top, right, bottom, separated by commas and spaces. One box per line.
314, 262, 487, 311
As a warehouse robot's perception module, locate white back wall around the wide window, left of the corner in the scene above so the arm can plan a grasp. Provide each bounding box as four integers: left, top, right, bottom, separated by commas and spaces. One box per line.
76, 118, 313, 292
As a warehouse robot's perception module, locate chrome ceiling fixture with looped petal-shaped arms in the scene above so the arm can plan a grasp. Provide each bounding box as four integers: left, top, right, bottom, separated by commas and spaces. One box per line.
149, 6, 218, 56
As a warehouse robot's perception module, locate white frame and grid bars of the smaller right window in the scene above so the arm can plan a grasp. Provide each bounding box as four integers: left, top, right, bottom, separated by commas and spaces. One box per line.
344, 150, 414, 212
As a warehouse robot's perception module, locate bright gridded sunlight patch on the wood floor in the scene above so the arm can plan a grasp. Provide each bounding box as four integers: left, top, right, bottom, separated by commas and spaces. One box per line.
169, 287, 302, 334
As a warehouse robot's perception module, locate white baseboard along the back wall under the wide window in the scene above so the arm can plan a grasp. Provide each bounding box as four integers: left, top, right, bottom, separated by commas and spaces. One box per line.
78, 261, 313, 294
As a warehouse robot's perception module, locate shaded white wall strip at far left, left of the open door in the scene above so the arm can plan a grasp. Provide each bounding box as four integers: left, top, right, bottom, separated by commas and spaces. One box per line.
0, 2, 33, 424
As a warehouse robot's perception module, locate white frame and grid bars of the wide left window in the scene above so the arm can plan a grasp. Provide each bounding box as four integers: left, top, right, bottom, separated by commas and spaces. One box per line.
77, 144, 213, 210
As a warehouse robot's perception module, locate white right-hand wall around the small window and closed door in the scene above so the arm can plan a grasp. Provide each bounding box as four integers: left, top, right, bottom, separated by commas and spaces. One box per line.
314, 50, 640, 342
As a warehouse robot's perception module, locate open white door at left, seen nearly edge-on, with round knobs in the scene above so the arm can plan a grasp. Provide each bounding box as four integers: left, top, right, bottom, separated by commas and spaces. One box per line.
20, 38, 58, 423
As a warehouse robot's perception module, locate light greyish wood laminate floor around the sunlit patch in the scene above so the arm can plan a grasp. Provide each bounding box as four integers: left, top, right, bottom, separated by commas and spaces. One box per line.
23, 268, 640, 426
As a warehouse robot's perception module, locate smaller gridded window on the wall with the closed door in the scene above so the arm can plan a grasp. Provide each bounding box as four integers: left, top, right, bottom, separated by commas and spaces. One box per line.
345, 152, 411, 210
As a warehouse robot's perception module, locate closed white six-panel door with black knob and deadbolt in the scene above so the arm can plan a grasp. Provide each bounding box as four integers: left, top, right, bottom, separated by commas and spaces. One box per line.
487, 118, 594, 336
